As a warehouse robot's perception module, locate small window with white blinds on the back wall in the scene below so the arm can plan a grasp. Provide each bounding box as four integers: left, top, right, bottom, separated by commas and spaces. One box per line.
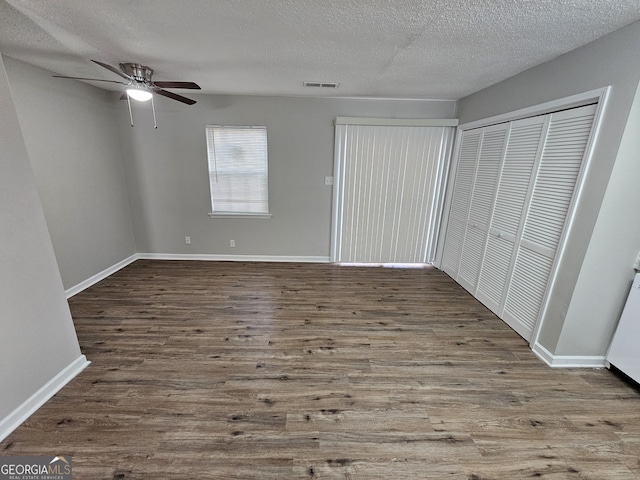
206, 125, 270, 217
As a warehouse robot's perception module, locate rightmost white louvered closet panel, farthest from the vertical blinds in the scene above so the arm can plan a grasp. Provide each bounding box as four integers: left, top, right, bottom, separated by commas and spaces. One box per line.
502, 105, 596, 339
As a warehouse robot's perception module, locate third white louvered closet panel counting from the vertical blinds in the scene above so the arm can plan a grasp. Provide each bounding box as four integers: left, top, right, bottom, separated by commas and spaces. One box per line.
476, 116, 549, 316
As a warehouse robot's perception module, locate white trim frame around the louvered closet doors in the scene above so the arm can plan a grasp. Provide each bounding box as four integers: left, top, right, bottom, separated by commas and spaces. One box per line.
434, 86, 611, 345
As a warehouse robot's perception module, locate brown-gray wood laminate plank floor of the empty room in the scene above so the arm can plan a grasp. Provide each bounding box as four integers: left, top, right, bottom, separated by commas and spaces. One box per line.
0, 261, 640, 480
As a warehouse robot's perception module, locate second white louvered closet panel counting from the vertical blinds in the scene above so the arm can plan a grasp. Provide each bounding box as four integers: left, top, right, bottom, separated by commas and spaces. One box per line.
458, 124, 510, 294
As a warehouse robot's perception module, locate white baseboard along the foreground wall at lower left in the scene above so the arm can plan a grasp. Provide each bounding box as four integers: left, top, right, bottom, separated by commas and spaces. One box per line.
0, 355, 91, 442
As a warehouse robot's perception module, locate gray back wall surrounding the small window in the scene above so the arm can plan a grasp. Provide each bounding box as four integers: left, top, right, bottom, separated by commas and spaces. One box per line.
116, 95, 455, 257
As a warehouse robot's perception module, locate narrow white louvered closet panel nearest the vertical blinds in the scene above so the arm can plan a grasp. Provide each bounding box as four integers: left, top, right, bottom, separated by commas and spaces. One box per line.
442, 129, 482, 278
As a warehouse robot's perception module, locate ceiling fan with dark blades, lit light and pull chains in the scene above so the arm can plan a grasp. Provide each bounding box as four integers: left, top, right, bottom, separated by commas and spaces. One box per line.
53, 60, 200, 128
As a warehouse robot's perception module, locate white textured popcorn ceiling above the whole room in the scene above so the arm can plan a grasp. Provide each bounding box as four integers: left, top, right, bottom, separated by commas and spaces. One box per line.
0, 0, 640, 99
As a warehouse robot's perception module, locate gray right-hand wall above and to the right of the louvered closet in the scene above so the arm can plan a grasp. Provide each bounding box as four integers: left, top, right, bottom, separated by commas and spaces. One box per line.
458, 19, 640, 356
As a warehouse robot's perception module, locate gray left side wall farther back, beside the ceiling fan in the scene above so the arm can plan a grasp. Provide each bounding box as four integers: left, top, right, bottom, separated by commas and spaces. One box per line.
5, 57, 136, 289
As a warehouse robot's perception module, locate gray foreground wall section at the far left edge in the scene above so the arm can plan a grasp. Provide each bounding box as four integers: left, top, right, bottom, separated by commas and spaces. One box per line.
0, 56, 80, 420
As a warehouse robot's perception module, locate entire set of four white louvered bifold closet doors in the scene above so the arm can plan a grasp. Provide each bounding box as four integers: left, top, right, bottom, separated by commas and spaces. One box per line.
442, 105, 596, 340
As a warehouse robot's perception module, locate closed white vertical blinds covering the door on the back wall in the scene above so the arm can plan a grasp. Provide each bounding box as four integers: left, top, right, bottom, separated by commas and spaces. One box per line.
332, 119, 453, 263
